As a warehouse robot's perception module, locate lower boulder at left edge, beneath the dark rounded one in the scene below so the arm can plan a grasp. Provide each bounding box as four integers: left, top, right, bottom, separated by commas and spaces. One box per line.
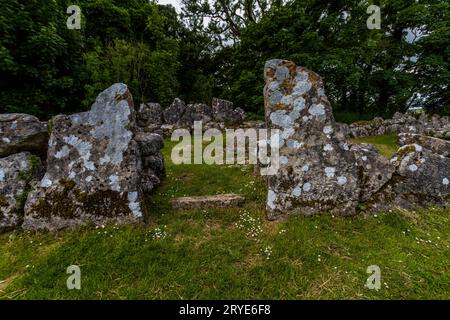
0, 152, 42, 232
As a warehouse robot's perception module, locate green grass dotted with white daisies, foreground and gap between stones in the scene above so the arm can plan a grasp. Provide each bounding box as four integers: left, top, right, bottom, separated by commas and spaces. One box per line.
0, 138, 450, 299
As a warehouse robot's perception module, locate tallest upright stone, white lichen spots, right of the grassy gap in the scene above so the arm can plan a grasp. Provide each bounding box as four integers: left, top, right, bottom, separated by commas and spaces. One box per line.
264, 60, 366, 219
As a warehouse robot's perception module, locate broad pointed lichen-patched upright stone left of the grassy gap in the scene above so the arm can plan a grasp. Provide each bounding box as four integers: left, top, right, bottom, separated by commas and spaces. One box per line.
23, 84, 162, 230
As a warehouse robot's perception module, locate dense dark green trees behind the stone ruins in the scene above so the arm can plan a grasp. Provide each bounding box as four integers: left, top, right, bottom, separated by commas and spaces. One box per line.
0, 0, 450, 118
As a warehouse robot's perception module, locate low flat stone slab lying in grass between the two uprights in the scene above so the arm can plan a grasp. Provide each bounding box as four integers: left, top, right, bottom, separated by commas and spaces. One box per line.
170, 194, 245, 210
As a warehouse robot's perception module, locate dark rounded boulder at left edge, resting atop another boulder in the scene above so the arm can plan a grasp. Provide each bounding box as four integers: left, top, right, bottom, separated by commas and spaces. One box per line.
0, 113, 48, 157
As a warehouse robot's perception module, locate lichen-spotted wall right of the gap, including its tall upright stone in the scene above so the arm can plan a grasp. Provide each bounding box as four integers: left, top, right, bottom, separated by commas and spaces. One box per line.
264, 59, 450, 219
